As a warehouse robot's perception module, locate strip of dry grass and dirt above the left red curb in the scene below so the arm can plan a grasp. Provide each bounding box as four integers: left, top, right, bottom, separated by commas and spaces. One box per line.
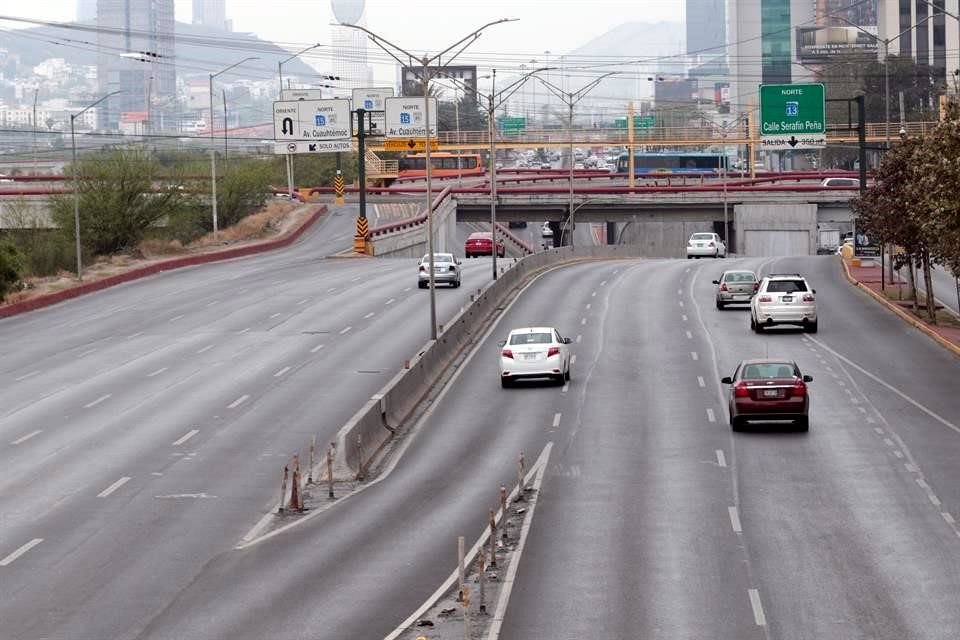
0, 202, 315, 306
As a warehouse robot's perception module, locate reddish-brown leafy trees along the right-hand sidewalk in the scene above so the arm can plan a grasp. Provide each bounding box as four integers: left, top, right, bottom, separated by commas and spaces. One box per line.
851, 104, 960, 324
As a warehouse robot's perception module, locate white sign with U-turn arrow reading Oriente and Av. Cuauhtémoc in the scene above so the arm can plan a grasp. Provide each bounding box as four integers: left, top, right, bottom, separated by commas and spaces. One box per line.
273, 98, 350, 141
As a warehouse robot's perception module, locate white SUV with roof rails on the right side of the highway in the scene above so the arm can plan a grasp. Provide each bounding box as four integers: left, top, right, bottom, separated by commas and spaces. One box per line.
750, 273, 817, 333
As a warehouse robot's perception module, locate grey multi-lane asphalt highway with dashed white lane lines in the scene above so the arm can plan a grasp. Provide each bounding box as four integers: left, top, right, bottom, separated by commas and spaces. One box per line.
0, 225, 960, 640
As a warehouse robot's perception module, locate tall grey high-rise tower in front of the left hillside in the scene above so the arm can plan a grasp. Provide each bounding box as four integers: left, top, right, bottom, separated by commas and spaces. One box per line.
97, 0, 177, 131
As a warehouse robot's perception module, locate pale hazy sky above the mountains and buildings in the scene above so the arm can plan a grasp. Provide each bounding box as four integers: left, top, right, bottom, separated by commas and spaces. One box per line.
0, 0, 684, 58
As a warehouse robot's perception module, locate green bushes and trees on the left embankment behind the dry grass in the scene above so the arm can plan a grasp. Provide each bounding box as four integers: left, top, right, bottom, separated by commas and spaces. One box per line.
0, 146, 356, 301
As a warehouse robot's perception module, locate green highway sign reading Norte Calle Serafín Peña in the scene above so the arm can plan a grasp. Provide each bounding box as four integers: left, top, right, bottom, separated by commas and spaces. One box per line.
760, 84, 827, 151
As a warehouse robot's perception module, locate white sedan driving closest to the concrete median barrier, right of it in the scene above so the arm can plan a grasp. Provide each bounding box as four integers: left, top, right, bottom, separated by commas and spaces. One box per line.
500, 327, 570, 388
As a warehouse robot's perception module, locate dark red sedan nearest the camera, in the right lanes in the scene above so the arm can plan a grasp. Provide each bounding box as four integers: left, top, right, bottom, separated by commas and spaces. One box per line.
720, 359, 813, 431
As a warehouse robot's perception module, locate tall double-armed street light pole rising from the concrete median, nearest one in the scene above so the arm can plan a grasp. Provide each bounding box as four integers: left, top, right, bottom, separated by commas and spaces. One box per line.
337, 18, 514, 340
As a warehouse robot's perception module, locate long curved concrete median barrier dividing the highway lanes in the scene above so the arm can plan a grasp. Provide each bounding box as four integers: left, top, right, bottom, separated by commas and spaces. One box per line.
335, 245, 640, 478
